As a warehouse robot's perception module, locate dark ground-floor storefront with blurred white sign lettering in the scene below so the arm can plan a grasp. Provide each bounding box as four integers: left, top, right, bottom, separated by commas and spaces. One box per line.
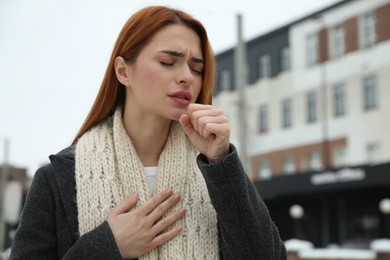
255, 163, 390, 248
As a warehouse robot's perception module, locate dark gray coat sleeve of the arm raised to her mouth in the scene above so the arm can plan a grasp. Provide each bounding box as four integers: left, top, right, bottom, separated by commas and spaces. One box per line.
197, 145, 286, 260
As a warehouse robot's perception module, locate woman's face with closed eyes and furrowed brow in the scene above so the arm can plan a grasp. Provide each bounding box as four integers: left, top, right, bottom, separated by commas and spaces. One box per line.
122, 24, 204, 120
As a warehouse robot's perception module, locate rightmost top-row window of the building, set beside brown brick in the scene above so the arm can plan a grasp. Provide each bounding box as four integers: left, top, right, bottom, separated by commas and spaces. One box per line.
359, 12, 376, 49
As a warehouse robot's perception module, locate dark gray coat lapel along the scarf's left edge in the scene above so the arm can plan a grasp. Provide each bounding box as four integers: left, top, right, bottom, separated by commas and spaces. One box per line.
49, 144, 79, 240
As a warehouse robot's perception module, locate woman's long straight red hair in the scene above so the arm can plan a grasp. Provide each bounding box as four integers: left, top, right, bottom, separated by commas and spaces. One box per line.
73, 6, 215, 143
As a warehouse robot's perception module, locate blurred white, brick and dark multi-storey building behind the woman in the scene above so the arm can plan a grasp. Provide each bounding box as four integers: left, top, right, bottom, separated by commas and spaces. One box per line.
214, 0, 390, 247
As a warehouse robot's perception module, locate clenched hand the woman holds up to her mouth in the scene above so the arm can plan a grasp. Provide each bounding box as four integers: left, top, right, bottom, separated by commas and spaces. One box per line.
179, 103, 230, 162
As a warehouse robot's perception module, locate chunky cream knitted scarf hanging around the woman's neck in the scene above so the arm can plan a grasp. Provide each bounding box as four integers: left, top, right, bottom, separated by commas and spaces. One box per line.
76, 109, 219, 260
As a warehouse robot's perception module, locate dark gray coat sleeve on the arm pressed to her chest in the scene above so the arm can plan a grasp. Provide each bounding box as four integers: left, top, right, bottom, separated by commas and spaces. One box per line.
10, 165, 122, 260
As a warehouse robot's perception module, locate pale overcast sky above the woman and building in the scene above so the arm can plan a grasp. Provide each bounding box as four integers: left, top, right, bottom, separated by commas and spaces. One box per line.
0, 0, 339, 175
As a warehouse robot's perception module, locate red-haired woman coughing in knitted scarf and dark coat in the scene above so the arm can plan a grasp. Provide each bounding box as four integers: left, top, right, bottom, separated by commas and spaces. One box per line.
11, 6, 286, 259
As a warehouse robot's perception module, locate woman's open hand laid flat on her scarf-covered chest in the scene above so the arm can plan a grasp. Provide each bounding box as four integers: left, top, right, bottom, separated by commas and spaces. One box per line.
107, 189, 185, 259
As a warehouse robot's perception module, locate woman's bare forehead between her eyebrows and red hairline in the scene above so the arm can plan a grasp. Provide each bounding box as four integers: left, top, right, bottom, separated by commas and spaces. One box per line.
145, 24, 203, 58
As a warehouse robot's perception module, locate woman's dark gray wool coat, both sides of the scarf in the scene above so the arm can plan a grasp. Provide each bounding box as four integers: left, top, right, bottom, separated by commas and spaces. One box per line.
10, 145, 286, 260
